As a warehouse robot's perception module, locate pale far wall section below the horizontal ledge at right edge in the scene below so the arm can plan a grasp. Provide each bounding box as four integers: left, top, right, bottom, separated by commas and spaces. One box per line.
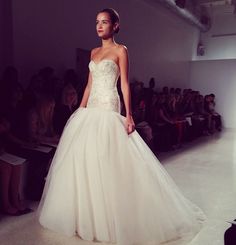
190, 59, 236, 128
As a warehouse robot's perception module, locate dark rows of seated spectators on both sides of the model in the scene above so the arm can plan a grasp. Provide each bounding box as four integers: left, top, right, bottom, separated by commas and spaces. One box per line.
0, 67, 222, 155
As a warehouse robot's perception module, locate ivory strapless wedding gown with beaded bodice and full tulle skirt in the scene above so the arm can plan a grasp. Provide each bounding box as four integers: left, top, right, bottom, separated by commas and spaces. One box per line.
38, 59, 204, 245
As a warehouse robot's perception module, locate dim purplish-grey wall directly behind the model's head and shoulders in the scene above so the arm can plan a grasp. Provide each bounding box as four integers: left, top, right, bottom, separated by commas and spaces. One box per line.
13, 0, 198, 87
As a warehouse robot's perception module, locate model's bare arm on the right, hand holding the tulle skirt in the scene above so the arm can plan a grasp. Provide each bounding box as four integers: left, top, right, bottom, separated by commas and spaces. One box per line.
119, 46, 135, 134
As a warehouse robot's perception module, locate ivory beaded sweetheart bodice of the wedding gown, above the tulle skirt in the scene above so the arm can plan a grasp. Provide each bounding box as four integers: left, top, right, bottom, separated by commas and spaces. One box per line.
87, 59, 120, 113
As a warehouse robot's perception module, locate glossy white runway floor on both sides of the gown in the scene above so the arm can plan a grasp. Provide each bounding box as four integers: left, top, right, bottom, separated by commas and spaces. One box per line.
0, 130, 236, 245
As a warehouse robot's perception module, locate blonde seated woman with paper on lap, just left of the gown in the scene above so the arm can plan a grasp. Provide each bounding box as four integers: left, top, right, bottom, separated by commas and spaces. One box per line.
21, 95, 59, 200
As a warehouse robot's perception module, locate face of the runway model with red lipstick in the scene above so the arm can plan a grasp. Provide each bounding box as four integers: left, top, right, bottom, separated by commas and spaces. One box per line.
96, 12, 115, 39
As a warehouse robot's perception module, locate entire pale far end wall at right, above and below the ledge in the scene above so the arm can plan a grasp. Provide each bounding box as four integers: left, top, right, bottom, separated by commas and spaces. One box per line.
189, 5, 236, 128
